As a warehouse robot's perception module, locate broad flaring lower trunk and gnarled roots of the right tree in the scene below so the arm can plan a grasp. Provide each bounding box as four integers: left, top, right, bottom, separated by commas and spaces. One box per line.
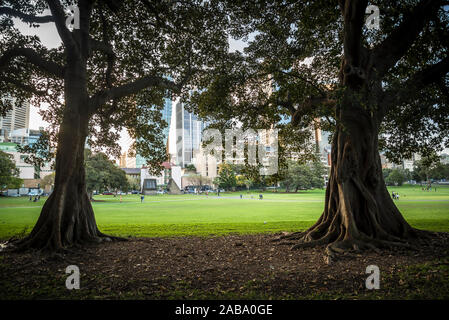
282, 90, 421, 255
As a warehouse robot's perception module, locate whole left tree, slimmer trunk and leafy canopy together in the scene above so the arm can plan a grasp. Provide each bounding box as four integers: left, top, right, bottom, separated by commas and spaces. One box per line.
0, 0, 228, 250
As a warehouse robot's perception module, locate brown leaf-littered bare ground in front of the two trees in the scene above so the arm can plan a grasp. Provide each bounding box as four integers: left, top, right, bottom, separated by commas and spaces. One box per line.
0, 233, 449, 299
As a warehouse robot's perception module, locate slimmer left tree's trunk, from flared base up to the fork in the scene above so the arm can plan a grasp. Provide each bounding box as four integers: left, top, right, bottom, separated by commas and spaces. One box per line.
15, 65, 117, 251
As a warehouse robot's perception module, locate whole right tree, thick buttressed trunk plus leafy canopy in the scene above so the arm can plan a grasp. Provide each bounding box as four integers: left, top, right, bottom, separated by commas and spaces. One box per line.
190, 0, 449, 255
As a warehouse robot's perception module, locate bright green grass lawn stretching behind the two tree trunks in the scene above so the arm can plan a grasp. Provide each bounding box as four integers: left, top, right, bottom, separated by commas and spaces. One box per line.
0, 186, 449, 239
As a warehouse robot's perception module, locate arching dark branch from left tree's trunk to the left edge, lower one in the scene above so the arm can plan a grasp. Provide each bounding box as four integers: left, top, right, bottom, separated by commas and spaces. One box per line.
0, 48, 64, 78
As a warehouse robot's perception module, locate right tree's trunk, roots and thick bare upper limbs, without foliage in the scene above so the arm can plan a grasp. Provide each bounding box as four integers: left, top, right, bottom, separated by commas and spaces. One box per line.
272, 0, 448, 255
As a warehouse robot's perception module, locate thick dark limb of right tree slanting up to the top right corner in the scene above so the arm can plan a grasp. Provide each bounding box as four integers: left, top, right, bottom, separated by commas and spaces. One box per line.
372, 0, 442, 77
